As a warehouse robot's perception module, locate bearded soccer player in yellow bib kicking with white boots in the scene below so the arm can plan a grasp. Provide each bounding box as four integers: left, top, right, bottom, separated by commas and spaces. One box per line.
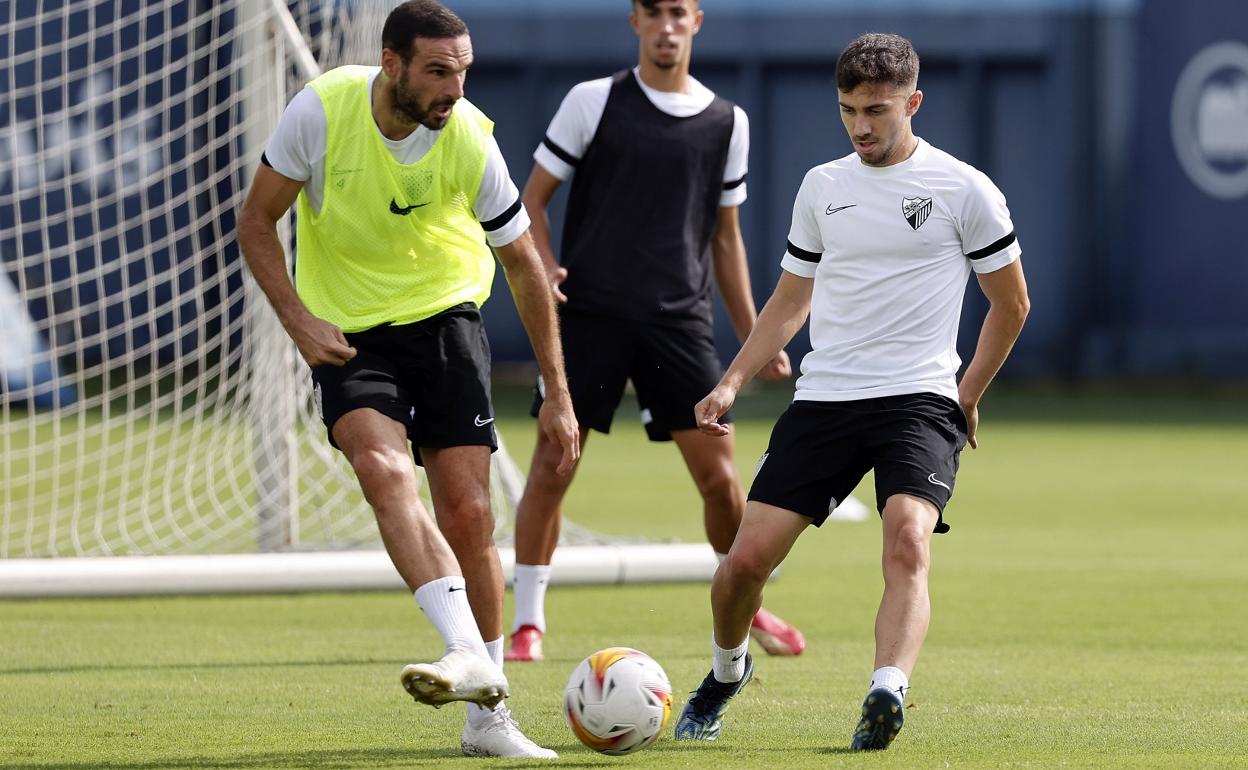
238, 0, 580, 759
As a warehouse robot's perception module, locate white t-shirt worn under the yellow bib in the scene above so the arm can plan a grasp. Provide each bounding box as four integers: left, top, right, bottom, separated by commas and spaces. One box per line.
265, 67, 529, 247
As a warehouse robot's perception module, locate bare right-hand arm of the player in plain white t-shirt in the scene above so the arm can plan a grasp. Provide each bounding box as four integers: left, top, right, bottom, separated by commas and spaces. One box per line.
957, 260, 1031, 449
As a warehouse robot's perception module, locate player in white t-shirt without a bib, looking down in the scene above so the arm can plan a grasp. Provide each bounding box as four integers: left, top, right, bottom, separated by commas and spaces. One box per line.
676, 34, 1030, 749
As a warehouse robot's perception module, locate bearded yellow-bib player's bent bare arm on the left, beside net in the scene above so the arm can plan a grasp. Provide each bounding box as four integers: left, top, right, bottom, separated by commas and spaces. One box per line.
238, 166, 356, 366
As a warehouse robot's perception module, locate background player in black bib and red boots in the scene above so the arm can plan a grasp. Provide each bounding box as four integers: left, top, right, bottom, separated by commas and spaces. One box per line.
507, 0, 805, 660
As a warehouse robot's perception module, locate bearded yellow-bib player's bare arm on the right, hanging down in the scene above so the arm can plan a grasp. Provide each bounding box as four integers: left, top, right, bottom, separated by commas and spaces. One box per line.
495, 231, 580, 473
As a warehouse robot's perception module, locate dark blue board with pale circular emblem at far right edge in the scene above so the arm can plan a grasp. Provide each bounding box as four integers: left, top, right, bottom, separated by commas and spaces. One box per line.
1126, 0, 1248, 376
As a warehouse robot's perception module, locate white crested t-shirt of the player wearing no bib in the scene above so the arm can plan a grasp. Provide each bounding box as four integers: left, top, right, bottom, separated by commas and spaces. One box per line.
780, 140, 1022, 401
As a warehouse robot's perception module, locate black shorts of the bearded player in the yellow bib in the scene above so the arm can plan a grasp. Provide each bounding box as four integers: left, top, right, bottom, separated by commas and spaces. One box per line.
312, 302, 498, 464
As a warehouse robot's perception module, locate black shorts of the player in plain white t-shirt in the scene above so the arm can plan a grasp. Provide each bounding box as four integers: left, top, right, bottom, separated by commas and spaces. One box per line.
749, 393, 967, 533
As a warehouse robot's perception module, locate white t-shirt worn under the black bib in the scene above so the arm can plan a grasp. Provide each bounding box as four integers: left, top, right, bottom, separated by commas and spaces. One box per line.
533, 67, 750, 206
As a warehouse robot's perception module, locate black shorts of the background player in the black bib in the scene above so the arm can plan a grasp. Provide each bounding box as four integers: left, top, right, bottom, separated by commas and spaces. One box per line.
532, 308, 733, 441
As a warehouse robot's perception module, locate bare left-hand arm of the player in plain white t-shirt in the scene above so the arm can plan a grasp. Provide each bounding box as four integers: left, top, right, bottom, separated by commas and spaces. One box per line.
694, 271, 815, 436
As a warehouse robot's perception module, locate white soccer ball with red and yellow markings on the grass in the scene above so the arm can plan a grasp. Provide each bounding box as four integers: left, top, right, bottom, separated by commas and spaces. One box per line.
563, 646, 671, 755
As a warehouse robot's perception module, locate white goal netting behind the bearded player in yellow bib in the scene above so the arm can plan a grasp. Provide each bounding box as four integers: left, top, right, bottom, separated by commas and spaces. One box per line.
0, 0, 539, 558
